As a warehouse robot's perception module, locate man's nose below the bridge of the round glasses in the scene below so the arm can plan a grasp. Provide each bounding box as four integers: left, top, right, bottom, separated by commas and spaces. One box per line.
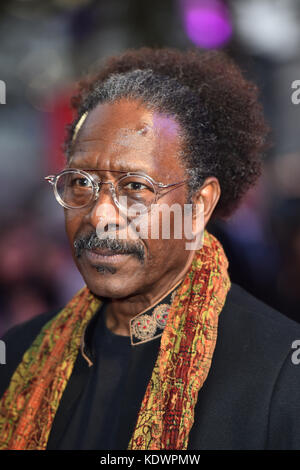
88, 182, 126, 235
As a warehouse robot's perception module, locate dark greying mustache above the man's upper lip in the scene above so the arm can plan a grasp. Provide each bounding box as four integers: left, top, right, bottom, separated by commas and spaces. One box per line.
73, 232, 145, 263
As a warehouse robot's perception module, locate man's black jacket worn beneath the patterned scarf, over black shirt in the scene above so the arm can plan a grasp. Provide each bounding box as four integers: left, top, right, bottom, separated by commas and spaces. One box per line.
0, 283, 300, 450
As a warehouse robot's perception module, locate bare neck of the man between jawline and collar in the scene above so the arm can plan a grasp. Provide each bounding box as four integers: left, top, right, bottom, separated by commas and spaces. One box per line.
106, 251, 195, 336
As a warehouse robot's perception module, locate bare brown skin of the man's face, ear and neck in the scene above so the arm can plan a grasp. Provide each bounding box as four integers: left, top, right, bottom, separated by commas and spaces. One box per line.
65, 99, 220, 335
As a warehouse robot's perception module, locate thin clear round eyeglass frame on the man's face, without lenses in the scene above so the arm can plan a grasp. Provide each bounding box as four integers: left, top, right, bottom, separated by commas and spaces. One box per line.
44, 168, 189, 212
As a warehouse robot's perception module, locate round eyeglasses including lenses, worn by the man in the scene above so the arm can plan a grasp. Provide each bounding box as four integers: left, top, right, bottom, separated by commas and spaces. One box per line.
45, 168, 188, 213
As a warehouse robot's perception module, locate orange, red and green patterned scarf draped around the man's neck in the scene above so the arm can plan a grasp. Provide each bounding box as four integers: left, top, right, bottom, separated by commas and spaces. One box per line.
0, 230, 230, 450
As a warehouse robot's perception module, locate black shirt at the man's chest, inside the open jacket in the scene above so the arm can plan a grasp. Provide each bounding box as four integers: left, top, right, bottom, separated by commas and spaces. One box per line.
59, 302, 131, 450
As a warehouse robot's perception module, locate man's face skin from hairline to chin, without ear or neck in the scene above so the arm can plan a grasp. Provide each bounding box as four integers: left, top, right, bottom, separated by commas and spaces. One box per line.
65, 99, 190, 298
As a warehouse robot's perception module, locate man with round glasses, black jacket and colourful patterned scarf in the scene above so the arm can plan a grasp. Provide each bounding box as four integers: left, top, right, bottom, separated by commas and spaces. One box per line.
0, 49, 300, 450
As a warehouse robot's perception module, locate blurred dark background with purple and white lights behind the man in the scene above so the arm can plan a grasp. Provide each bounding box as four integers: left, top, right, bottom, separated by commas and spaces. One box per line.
0, 0, 300, 336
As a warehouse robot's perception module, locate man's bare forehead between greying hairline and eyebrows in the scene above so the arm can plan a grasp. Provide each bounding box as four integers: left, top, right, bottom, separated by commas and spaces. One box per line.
69, 99, 183, 179
